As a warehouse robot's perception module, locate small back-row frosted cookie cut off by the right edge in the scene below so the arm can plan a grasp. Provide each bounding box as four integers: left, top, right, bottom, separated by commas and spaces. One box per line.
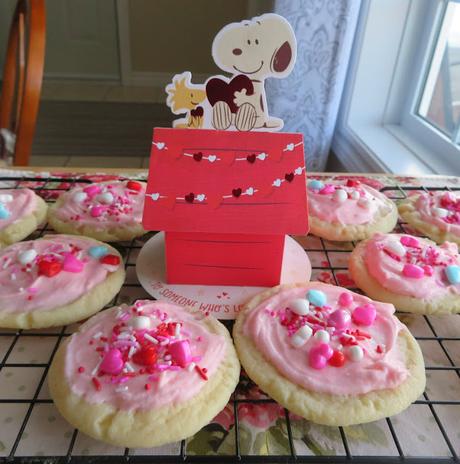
398, 191, 460, 245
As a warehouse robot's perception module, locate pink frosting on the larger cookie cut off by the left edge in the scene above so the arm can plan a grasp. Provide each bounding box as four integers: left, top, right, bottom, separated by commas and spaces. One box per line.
0, 235, 119, 313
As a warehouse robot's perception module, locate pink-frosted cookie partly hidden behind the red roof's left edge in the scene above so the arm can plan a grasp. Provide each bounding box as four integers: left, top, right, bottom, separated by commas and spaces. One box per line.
48, 180, 146, 242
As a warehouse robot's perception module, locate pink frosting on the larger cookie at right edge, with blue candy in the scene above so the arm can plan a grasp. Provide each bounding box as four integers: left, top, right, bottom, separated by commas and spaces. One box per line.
364, 233, 460, 299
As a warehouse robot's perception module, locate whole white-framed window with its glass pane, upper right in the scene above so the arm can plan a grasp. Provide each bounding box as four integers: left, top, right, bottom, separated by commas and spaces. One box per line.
332, 0, 460, 175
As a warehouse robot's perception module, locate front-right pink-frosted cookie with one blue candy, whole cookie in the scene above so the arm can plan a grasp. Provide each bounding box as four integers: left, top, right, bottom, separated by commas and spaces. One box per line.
233, 282, 425, 425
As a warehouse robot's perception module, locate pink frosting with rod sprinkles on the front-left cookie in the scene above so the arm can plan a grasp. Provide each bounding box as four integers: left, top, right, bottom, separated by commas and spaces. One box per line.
65, 301, 226, 410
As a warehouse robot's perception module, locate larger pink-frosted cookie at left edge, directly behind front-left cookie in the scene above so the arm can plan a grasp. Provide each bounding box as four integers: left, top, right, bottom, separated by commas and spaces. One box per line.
0, 235, 125, 329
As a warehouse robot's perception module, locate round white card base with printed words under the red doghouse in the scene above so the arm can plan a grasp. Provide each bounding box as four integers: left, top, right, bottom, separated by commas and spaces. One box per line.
136, 232, 311, 319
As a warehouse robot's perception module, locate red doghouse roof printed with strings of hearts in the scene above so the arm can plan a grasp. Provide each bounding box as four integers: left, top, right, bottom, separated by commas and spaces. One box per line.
143, 128, 308, 234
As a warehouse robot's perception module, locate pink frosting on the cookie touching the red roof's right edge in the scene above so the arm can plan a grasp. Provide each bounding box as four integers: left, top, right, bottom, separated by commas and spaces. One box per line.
308, 180, 390, 224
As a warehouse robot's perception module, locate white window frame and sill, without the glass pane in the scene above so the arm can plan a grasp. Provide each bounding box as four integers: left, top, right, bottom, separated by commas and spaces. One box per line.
332, 0, 460, 175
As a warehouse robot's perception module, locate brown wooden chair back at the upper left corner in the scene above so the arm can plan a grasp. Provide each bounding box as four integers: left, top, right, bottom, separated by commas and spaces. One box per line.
0, 0, 46, 166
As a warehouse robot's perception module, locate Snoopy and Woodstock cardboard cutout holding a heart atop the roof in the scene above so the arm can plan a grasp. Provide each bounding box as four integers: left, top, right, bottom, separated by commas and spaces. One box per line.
166, 13, 297, 132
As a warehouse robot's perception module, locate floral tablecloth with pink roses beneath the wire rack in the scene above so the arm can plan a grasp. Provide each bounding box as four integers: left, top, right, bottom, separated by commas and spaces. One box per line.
0, 170, 460, 462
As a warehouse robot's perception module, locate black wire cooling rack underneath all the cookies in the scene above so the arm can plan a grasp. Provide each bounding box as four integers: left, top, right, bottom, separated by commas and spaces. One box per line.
0, 177, 460, 464
